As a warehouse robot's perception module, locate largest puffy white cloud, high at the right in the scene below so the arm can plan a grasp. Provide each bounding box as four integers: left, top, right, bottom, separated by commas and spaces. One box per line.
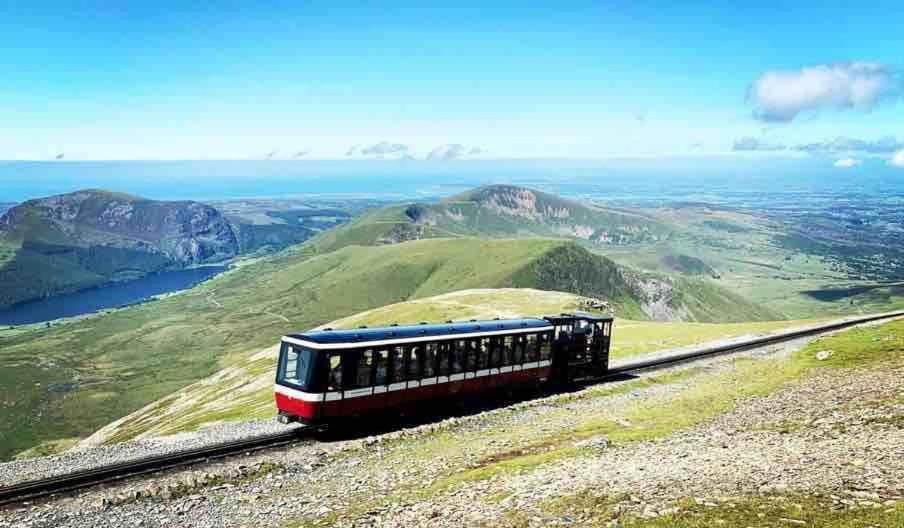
747, 62, 901, 122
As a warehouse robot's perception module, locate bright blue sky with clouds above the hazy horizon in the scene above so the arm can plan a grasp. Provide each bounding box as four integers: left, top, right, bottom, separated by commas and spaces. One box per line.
0, 1, 904, 167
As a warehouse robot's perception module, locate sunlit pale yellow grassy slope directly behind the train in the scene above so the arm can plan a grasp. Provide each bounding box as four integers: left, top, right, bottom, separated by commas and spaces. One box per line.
81, 289, 820, 443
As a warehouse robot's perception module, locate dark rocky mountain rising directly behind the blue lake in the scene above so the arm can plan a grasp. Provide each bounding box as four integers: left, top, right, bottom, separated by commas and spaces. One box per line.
0, 190, 240, 306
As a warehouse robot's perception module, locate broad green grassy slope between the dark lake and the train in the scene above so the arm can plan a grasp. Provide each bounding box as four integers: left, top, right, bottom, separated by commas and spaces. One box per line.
0, 239, 620, 458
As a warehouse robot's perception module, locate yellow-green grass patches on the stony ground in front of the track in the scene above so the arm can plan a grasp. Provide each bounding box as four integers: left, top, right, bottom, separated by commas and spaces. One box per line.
291, 321, 904, 528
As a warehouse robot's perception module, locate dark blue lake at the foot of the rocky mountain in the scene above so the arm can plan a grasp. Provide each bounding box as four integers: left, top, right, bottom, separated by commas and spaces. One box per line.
0, 266, 228, 325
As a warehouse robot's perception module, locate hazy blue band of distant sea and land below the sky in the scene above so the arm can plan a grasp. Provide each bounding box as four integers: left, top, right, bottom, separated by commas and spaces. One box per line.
0, 157, 904, 203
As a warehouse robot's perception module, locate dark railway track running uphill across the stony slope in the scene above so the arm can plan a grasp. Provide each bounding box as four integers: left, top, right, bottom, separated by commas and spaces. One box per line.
0, 311, 904, 506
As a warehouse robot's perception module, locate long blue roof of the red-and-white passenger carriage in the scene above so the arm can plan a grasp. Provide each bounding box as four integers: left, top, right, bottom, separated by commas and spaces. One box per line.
286, 318, 552, 345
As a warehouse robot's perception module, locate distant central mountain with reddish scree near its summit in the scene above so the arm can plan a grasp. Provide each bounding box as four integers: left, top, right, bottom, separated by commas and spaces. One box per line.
317, 185, 670, 251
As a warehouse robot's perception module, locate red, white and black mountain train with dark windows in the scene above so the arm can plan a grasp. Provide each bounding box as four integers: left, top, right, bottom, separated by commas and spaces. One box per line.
274, 312, 613, 426
